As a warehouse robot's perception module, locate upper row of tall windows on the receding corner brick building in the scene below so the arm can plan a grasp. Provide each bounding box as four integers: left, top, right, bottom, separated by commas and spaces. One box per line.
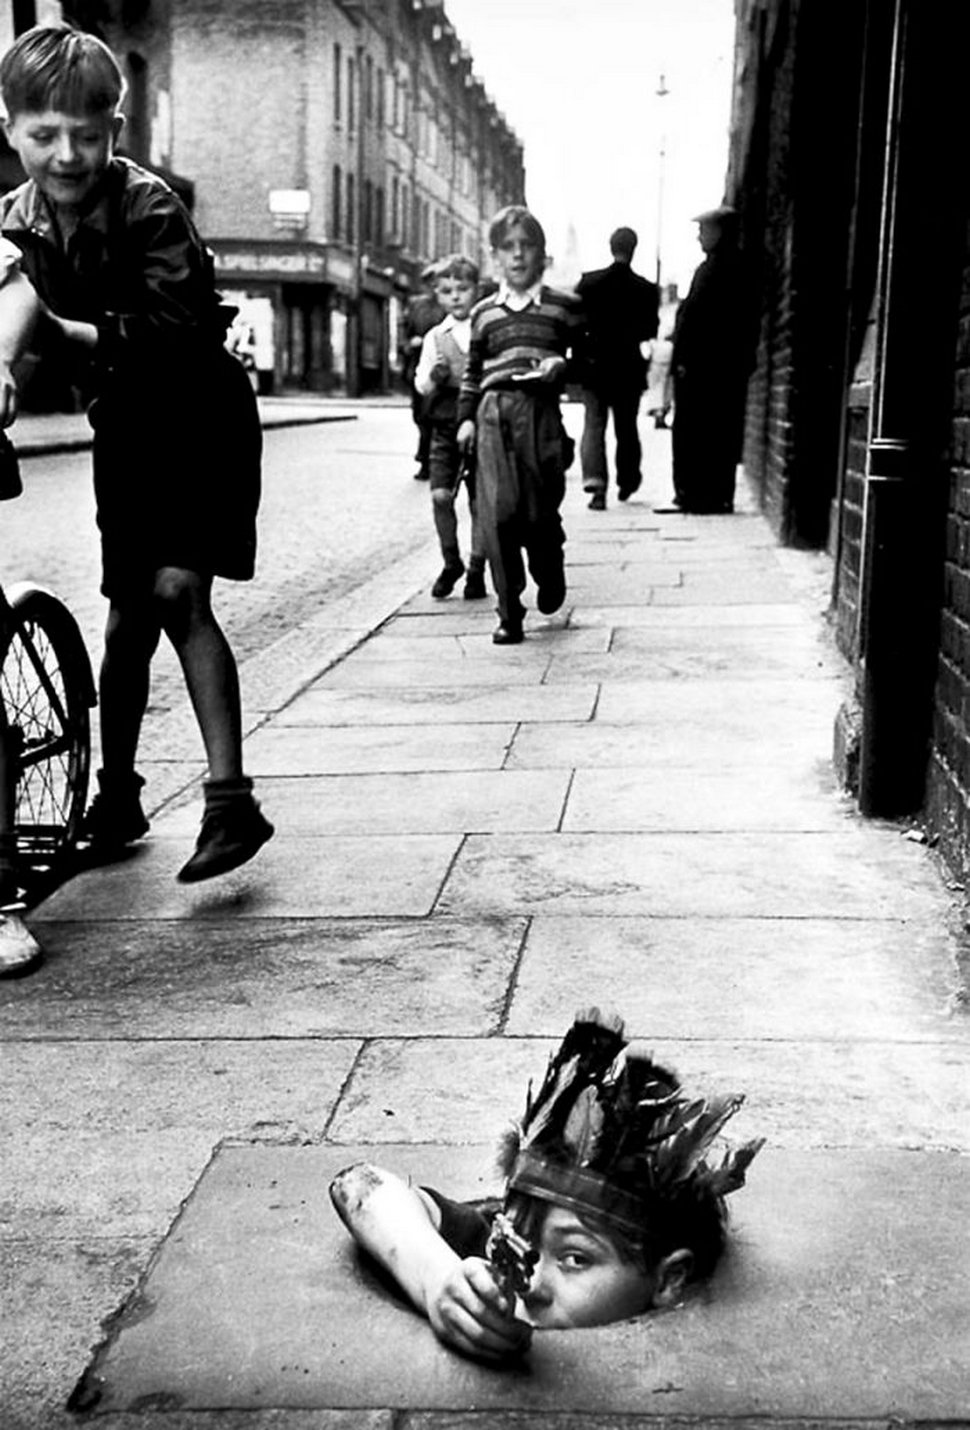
332, 43, 483, 194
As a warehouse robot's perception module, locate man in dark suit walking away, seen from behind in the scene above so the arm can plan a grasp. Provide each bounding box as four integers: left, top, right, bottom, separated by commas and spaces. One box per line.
577, 229, 660, 512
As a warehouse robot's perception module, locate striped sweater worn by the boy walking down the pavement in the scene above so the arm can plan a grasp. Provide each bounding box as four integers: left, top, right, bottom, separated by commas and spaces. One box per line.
458, 286, 584, 422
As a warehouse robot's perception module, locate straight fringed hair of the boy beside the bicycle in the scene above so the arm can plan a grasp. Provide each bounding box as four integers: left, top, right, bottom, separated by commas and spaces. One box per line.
0, 24, 124, 119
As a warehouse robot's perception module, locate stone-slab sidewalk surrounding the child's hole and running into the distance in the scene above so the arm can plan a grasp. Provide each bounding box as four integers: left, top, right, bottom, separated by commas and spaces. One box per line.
0, 412, 970, 1430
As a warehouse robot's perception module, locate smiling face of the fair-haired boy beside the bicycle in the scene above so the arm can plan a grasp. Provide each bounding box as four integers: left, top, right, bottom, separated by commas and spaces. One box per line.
4, 109, 123, 209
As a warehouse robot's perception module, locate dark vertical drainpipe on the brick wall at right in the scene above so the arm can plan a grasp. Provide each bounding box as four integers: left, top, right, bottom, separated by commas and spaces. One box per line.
858, 0, 930, 818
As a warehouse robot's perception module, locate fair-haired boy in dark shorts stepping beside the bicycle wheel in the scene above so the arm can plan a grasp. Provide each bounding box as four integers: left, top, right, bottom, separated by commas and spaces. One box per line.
0, 24, 273, 882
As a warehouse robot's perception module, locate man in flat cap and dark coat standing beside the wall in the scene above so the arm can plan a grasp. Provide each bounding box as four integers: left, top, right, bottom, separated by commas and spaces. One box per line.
671, 206, 758, 512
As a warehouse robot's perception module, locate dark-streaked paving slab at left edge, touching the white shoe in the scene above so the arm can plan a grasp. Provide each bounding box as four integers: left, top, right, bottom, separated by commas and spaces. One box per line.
0, 918, 526, 1045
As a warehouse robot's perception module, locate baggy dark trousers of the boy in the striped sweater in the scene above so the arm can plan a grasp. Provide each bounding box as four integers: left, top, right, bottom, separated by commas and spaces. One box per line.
476, 392, 565, 625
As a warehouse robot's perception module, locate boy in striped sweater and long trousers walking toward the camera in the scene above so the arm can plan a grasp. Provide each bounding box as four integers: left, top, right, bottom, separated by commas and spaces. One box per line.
458, 204, 582, 645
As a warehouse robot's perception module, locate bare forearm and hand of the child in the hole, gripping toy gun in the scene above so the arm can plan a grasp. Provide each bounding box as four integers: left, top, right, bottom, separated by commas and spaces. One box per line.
330, 1163, 531, 1360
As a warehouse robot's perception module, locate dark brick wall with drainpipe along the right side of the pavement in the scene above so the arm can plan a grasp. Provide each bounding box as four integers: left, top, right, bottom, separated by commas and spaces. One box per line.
725, 0, 970, 874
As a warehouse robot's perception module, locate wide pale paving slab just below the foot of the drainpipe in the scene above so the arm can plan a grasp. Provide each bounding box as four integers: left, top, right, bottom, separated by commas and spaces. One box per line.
436, 827, 941, 921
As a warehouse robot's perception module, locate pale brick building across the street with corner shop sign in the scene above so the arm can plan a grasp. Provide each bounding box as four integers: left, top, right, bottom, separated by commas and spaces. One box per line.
0, 0, 525, 392
